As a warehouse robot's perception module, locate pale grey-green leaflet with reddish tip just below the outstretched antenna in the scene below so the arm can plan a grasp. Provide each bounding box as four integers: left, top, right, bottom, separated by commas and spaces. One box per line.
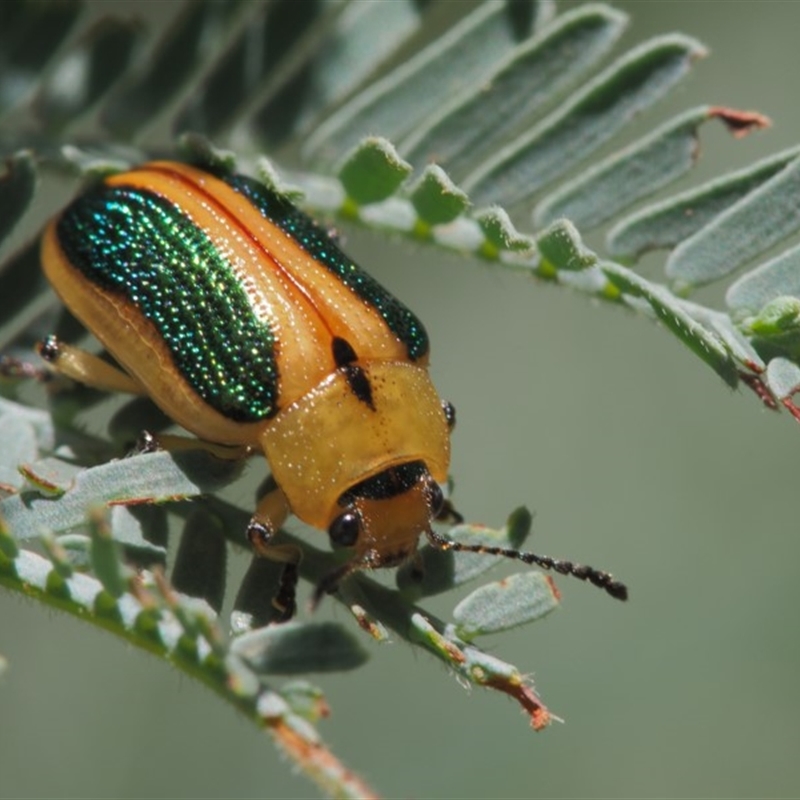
453, 572, 559, 641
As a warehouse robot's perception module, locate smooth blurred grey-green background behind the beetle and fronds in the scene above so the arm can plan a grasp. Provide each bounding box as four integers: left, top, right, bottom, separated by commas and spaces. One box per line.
0, 0, 800, 798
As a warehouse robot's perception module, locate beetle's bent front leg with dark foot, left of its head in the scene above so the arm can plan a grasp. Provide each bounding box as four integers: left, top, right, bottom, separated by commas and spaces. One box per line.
247, 482, 302, 622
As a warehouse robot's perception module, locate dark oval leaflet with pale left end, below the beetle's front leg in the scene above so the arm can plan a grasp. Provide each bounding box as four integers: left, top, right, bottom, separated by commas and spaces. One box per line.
231, 622, 367, 675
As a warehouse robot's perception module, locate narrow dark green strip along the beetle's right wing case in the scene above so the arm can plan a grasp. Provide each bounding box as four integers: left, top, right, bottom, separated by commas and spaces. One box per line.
213, 171, 430, 361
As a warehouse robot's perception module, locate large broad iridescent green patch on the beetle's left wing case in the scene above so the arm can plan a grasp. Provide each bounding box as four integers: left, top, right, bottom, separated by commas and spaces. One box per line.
56, 184, 278, 422
